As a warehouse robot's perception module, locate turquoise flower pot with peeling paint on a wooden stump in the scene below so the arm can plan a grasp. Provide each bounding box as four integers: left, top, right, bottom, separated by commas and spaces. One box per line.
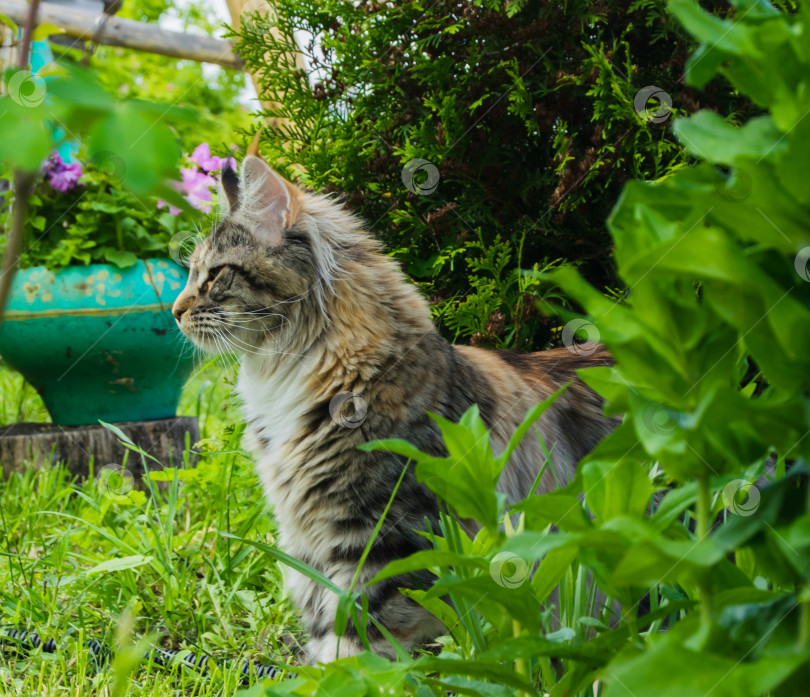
0, 259, 193, 425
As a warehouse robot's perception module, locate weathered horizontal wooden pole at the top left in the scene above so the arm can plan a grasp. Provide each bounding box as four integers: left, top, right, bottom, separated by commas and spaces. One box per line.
0, 0, 244, 70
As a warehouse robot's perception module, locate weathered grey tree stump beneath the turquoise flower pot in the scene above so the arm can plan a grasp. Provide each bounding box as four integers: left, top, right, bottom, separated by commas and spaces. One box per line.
0, 416, 200, 485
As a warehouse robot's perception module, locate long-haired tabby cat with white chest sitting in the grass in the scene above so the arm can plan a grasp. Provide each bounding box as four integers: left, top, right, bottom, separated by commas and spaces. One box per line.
173, 155, 611, 662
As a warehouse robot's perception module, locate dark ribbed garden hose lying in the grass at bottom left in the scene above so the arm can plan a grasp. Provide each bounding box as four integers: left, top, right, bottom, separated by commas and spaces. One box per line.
0, 627, 283, 684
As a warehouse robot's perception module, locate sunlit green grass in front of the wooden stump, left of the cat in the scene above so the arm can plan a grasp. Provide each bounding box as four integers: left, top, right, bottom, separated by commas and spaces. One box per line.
0, 364, 296, 696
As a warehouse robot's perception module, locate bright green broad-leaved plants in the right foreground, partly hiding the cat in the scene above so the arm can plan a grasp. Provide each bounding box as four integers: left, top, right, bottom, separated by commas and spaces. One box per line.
237, 0, 810, 697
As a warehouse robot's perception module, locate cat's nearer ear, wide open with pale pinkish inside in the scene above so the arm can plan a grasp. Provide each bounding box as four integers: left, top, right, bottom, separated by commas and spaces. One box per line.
239, 155, 297, 246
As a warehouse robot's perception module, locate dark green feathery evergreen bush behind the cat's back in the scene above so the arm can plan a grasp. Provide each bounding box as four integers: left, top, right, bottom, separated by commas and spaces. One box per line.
230, 0, 747, 349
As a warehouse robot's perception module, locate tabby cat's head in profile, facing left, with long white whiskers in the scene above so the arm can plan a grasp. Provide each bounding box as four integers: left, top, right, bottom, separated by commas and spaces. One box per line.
172, 155, 352, 353
